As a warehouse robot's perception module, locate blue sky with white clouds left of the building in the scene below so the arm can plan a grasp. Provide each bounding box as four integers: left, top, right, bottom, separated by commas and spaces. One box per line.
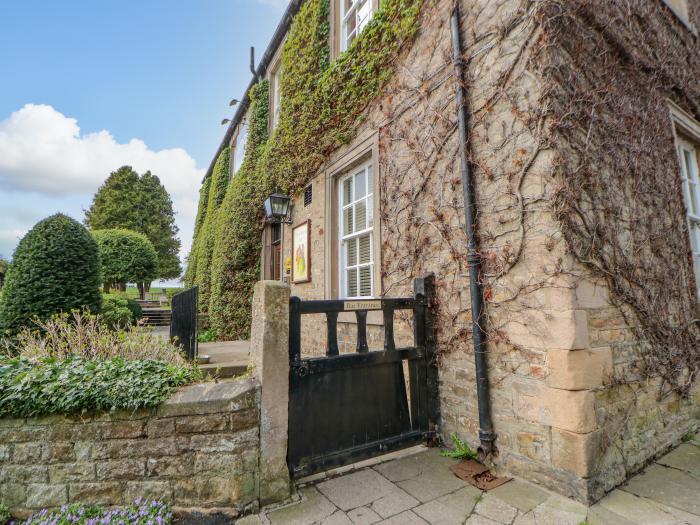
0, 0, 286, 278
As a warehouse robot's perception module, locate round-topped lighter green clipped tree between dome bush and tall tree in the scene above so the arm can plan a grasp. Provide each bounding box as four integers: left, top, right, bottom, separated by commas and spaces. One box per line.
92, 229, 158, 299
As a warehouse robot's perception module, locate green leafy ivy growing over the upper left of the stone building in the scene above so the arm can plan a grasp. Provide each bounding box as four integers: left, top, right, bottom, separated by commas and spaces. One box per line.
185, 0, 423, 339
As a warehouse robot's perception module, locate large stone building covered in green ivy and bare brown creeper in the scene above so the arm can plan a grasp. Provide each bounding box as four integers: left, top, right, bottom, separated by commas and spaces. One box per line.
187, 0, 700, 501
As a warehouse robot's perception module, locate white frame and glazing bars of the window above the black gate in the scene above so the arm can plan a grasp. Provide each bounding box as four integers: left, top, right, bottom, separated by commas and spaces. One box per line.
337, 161, 376, 299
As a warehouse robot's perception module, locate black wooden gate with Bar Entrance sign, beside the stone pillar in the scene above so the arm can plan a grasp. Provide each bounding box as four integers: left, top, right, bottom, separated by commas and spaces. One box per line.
287, 275, 438, 477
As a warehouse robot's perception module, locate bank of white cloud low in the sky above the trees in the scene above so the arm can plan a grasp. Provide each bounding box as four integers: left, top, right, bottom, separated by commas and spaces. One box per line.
0, 104, 204, 274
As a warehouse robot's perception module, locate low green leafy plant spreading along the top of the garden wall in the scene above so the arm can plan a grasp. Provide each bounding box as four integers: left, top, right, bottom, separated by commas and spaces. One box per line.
0, 356, 199, 417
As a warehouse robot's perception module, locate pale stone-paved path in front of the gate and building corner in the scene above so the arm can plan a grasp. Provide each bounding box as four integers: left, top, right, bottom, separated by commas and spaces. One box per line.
237, 435, 700, 525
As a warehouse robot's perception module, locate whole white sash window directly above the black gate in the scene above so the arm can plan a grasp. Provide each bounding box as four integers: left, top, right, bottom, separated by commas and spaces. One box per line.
338, 164, 374, 299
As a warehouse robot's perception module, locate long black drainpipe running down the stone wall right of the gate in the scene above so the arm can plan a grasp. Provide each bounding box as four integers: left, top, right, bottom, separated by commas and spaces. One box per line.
452, 5, 496, 456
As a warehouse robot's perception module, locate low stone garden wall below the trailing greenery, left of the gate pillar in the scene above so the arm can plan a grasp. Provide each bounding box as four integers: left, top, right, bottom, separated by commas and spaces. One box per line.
0, 379, 260, 517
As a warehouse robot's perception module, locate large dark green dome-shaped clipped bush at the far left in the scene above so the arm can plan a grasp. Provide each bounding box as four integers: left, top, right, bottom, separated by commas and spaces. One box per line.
0, 213, 102, 335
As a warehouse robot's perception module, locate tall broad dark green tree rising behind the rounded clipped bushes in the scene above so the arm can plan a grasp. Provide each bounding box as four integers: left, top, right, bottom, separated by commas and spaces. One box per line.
85, 166, 182, 282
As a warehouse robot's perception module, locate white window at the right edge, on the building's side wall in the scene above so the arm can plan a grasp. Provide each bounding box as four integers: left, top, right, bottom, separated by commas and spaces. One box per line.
677, 137, 700, 299
